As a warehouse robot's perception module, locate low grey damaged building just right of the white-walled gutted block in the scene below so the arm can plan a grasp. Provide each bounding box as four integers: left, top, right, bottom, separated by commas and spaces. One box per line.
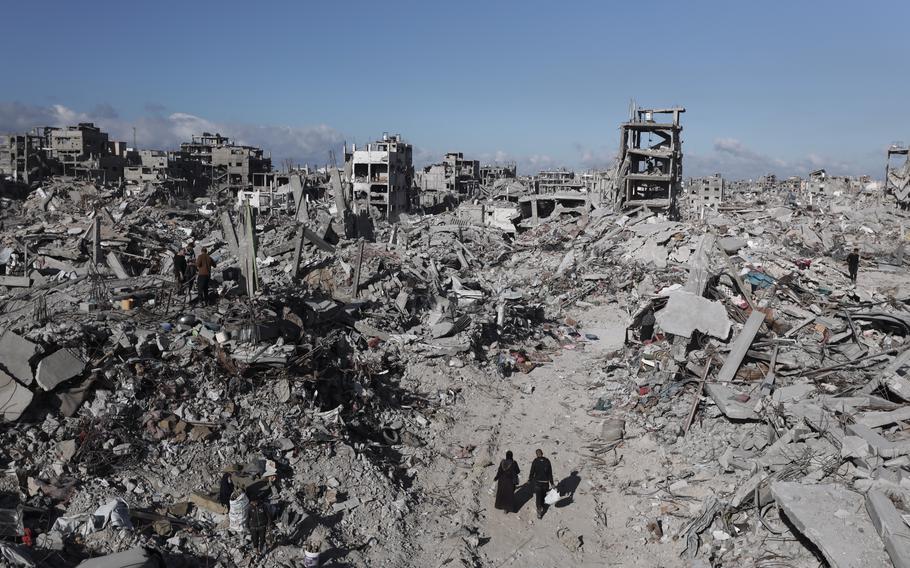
415, 152, 481, 209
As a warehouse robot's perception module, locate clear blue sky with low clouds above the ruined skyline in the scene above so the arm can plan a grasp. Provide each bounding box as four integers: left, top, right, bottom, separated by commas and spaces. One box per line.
0, 0, 910, 177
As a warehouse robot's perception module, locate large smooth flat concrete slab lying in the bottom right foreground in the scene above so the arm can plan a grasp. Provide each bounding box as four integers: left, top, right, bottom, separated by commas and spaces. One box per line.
771, 481, 890, 568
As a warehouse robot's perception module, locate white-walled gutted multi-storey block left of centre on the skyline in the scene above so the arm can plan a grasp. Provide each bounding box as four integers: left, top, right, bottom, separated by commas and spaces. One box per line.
345, 134, 414, 219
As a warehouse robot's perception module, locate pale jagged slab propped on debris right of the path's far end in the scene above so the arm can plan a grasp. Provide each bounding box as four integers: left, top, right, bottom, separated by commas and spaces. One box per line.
656, 290, 730, 339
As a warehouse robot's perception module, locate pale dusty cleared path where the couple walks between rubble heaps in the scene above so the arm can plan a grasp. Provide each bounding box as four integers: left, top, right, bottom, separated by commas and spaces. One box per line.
415, 305, 688, 567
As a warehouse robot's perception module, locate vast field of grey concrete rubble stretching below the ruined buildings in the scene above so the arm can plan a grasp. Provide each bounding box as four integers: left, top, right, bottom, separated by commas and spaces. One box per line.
0, 177, 910, 568
